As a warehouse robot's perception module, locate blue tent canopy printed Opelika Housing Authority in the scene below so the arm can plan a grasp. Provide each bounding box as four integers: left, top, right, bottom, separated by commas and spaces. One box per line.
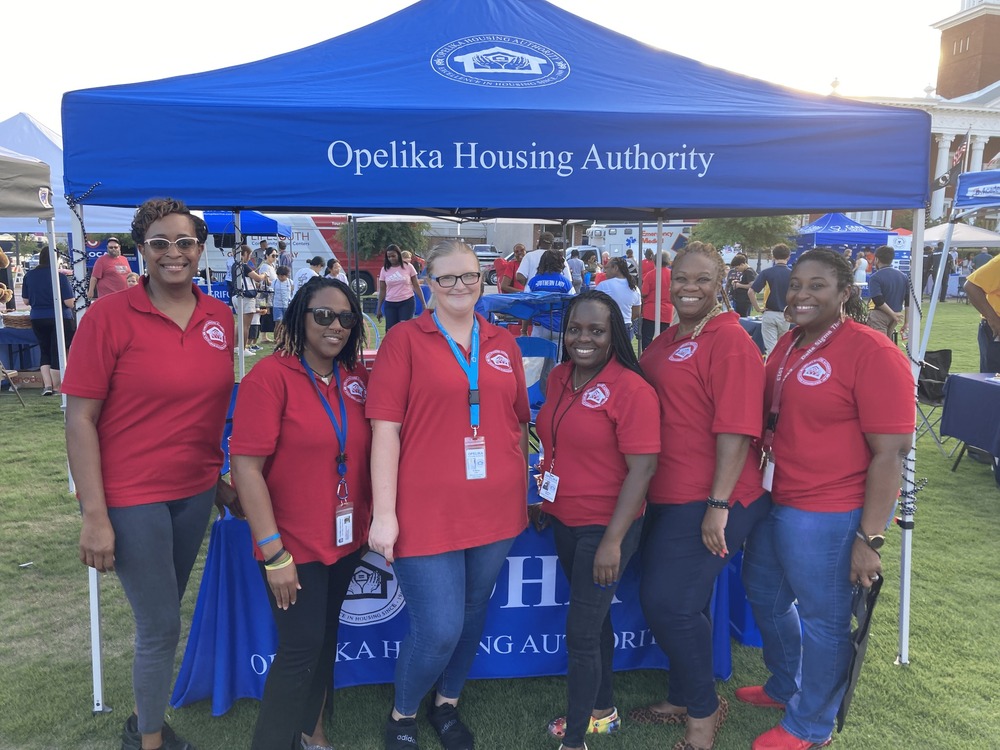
63, 0, 930, 219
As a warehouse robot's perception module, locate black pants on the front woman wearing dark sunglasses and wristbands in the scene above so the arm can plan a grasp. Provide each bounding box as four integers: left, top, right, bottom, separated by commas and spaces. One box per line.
251, 550, 361, 750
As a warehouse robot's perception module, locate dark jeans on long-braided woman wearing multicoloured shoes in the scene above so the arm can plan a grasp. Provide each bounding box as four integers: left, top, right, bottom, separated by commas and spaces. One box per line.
552, 518, 642, 747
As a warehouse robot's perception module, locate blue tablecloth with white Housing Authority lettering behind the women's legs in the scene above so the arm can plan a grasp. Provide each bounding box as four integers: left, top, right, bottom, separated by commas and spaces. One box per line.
171, 518, 760, 716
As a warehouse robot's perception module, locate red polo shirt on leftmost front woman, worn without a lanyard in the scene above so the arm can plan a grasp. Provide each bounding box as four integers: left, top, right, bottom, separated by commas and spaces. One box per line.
62, 280, 233, 507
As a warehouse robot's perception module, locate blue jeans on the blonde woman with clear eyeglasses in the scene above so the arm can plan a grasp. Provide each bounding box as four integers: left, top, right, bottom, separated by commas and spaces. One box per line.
392, 537, 514, 716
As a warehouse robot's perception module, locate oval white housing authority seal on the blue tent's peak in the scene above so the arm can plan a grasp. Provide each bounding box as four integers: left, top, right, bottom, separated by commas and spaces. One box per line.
431, 34, 570, 88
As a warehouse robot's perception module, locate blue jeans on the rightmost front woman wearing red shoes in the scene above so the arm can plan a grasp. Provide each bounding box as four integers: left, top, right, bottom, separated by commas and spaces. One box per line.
743, 505, 861, 742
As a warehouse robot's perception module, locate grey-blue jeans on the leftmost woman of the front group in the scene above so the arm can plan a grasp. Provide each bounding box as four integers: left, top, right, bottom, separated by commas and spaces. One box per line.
108, 484, 215, 734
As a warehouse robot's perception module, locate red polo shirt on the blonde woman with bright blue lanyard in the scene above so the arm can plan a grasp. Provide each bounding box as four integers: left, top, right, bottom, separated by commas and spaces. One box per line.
365, 312, 530, 557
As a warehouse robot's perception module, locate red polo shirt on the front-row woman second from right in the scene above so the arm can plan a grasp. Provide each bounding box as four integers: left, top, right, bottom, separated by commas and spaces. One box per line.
640, 313, 764, 505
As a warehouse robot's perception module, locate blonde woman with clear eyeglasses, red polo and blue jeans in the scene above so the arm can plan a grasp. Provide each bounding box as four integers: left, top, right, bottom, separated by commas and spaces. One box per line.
366, 241, 530, 750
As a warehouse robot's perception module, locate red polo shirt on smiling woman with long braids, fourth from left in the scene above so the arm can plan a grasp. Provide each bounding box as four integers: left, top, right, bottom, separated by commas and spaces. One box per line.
535, 358, 660, 526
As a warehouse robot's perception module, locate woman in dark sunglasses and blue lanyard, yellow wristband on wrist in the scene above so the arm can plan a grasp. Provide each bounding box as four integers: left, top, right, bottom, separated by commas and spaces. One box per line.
230, 277, 371, 750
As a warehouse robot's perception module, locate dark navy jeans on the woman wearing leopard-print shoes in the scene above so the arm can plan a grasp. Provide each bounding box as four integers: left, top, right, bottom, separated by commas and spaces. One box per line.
639, 493, 771, 719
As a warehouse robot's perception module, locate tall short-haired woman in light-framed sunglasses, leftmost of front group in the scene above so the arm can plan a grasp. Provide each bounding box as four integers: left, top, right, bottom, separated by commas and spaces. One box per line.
63, 198, 240, 750
